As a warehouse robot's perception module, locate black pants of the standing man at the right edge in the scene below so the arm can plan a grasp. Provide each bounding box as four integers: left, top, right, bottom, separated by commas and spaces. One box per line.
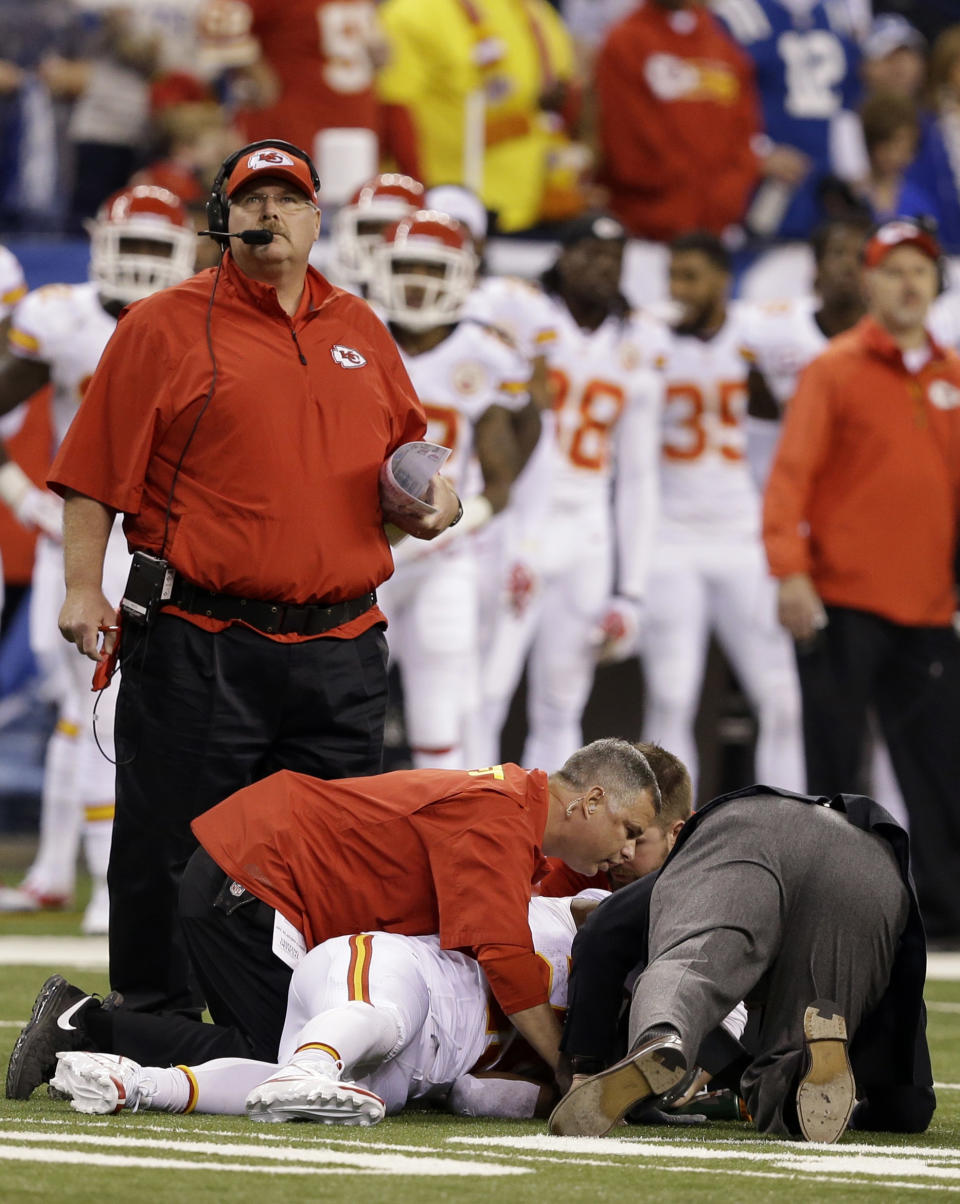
797, 607, 960, 938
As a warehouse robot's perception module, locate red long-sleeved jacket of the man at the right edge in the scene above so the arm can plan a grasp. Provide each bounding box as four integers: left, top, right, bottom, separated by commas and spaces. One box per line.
764, 317, 960, 627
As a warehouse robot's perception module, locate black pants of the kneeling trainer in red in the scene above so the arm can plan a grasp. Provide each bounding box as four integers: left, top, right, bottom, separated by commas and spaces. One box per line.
86, 849, 293, 1066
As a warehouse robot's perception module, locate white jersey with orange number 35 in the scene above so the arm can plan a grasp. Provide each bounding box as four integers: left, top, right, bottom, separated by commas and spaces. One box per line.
660, 313, 760, 533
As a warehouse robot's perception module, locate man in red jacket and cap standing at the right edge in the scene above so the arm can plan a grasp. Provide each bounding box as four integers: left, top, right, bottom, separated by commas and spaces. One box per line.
764, 219, 960, 945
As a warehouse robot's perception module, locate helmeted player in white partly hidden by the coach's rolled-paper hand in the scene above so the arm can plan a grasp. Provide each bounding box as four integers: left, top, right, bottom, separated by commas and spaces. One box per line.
371, 211, 528, 768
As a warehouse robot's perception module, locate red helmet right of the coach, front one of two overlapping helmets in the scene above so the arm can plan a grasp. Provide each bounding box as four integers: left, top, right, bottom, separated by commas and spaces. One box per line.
370, 209, 477, 330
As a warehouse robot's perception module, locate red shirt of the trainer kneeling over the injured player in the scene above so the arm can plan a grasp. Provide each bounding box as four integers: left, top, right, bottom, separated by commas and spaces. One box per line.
192, 765, 549, 1015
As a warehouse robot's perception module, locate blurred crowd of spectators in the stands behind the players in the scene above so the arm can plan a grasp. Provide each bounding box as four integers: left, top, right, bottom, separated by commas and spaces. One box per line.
0, 0, 960, 253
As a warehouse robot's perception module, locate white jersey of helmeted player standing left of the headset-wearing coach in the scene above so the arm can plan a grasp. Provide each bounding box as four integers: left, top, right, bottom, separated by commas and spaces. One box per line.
7, 283, 117, 447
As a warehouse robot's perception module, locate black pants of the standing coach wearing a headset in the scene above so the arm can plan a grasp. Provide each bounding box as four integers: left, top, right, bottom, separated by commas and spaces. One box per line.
107, 614, 387, 1016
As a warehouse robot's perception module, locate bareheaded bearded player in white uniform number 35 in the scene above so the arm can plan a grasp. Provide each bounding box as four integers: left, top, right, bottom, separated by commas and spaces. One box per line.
642, 234, 803, 790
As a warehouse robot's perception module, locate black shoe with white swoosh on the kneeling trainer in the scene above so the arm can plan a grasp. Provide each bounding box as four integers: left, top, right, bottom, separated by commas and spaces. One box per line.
6, 974, 100, 1099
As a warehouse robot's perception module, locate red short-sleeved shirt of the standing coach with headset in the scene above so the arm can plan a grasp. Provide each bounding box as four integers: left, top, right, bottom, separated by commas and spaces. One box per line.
48, 253, 426, 641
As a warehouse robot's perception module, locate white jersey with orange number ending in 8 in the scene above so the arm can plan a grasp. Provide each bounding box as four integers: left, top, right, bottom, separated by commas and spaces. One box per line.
548, 299, 662, 510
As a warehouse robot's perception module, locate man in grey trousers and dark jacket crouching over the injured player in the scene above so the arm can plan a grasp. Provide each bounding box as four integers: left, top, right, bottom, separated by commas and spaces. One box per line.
550, 786, 935, 1141
